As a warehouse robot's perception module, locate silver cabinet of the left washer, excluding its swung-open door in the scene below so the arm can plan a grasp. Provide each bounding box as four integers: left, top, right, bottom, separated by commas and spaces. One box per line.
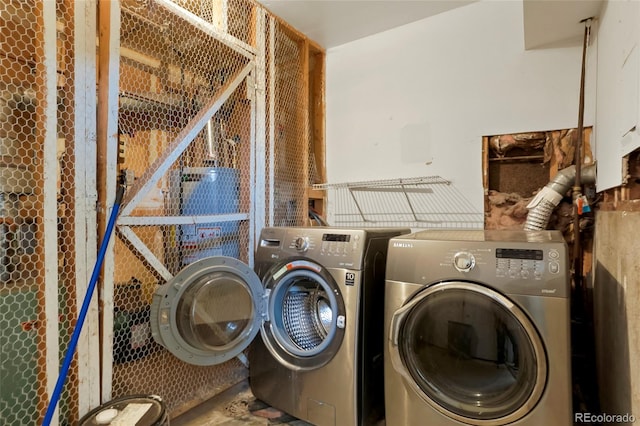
249, 227, 410, 426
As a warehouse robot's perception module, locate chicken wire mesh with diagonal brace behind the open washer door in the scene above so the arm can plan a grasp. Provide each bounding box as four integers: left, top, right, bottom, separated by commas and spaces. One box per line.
112, 0, 316, 416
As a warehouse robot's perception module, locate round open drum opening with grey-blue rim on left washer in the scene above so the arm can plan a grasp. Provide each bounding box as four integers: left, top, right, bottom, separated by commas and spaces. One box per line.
262, 259, 346, 369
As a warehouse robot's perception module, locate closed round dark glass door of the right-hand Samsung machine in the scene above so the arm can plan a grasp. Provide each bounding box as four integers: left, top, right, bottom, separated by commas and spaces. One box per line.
395, 282, 547, 424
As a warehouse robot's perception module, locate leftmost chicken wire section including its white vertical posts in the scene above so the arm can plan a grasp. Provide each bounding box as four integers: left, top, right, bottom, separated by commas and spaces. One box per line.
0, 0, 100, 424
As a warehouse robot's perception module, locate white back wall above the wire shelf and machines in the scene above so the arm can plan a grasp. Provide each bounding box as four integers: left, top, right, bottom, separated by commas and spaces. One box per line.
326, 1, 595, 218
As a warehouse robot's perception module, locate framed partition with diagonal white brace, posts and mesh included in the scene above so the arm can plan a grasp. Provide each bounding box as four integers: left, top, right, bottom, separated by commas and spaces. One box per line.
99, 0, 324, 416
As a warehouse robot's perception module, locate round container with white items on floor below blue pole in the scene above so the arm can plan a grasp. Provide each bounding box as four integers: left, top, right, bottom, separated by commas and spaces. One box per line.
78, 395, 169, 426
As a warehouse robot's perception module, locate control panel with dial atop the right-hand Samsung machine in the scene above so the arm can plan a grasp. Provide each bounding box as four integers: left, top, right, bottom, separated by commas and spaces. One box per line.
386, 230, 570, 297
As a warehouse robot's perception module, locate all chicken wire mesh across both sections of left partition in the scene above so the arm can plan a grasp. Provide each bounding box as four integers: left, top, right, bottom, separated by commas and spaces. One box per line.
0, 0, 320, 424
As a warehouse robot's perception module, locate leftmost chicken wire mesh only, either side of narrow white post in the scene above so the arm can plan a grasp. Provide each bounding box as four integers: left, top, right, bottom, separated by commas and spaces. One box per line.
0, 0, 78, 425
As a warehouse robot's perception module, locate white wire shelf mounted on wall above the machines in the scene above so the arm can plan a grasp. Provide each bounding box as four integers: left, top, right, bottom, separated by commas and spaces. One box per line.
312, 176, 484, 229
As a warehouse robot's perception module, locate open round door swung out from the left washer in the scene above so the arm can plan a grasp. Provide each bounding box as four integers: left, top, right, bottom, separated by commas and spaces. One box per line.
151, 256, 265, 365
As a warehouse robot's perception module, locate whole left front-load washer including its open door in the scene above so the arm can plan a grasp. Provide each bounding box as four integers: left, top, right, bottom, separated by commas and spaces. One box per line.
151, 227, 409, 426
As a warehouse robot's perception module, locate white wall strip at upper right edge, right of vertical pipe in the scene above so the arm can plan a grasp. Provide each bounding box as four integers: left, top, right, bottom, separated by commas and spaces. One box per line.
595, 1, 640, 191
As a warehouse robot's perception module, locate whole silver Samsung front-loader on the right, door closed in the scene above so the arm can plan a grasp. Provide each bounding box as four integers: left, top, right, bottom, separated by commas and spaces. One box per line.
384, 230, 573, 426
